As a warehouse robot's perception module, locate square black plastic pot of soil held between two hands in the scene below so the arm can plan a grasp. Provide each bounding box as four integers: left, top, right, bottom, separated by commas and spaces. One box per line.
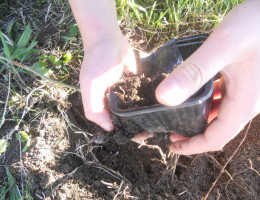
109, 35, 213, 137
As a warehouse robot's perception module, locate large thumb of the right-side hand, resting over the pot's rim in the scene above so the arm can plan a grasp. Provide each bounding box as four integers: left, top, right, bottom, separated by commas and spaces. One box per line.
155, 36, 228, 106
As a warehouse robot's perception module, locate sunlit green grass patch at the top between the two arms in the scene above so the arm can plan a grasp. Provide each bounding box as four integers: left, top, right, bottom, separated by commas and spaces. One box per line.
116, 0, 243, 47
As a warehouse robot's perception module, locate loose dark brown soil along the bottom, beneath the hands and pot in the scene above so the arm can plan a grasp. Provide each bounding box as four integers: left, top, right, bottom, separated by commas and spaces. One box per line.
21, 108, 260, 200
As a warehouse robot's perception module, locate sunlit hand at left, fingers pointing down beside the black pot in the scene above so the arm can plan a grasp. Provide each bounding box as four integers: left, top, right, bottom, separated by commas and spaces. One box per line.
80, 36, 136, 132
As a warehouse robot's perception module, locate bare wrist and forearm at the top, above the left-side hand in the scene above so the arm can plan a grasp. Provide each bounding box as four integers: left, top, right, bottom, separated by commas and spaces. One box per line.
69, 0, 122, 46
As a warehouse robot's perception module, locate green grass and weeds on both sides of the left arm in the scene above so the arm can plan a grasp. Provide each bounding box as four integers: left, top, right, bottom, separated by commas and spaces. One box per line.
0, 0, 246, 199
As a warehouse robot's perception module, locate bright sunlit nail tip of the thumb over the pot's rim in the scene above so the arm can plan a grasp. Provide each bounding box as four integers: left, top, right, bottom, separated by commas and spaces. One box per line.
156, 81, 186, 106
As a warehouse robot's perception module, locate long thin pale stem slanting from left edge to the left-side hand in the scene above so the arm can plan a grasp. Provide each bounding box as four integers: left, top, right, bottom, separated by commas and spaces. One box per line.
0, 56, 80, 91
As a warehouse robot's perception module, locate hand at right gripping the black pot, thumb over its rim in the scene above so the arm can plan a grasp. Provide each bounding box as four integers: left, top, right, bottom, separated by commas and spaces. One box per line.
156, 0, 260, 155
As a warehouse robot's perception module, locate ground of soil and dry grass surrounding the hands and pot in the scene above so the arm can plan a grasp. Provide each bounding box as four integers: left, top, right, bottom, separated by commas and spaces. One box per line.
0, 0, 260, 200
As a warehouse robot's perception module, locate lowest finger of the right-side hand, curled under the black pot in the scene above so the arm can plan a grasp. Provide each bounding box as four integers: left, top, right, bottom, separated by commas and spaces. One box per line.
170, 96, 251, 155
